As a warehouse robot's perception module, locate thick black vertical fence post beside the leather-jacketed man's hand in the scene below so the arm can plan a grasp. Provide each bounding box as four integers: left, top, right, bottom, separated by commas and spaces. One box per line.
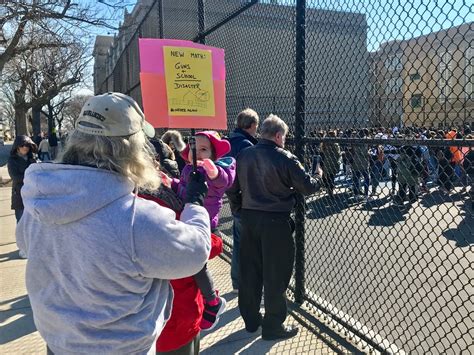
295, 0, 306, 304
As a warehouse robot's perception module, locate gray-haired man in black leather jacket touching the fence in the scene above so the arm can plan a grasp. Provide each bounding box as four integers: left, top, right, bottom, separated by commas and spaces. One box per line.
228, 115, 322, 340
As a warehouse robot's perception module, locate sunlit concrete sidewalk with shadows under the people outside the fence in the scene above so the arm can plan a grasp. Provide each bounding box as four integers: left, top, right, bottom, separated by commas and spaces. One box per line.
0, 187, 352, 355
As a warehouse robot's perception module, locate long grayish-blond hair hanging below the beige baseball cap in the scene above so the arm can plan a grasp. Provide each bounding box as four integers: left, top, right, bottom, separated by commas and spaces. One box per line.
58, 130, 160, 191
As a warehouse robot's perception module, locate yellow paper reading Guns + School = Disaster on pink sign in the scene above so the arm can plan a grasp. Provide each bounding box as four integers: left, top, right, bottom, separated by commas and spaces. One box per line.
163, 46, 215, 116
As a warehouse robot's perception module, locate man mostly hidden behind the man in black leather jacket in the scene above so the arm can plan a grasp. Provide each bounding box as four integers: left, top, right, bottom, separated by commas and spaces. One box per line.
227, 108, 259, 293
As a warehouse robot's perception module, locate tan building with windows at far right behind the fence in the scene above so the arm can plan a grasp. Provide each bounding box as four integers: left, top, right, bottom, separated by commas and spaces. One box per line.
371, 22, 474, 128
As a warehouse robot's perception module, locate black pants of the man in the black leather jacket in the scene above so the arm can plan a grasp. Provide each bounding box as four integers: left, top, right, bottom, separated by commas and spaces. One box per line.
239, 210, 295, 332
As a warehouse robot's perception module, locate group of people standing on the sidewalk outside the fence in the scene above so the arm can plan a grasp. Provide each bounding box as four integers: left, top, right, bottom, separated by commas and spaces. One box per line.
8, 93, 324, 354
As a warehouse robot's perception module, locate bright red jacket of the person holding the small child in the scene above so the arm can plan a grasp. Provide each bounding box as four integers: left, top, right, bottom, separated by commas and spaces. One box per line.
140, 195, 222, 352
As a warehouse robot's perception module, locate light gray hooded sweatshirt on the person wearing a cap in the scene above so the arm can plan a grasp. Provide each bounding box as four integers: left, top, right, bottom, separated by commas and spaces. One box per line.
16, 163, 211, 354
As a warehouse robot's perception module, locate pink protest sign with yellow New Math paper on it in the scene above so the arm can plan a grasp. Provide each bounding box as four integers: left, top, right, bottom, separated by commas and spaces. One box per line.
139, 38, 227, 129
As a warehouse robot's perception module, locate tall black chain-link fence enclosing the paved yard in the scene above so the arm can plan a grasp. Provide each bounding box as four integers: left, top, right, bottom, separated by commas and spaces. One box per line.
97, 0, 474, 353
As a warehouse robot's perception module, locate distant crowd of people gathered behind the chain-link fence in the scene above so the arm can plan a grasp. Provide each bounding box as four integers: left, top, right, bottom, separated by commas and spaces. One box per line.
310, 125, 474, 207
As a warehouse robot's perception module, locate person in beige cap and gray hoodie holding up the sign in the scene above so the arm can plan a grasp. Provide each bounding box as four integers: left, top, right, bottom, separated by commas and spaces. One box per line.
16, 93, 211, 354
